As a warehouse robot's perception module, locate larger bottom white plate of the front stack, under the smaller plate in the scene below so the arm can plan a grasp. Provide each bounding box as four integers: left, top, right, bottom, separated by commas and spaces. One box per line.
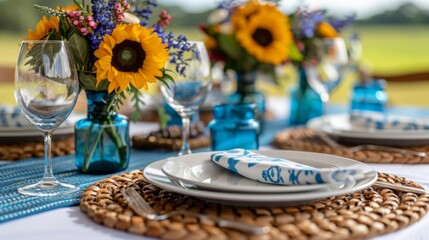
144, 150, 377, 206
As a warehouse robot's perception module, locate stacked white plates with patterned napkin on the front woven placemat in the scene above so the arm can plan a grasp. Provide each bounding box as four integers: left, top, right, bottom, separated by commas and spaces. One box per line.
144, 149, 376, 206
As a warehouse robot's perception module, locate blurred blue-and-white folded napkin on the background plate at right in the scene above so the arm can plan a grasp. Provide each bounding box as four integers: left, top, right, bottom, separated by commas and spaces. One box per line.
350, 111, 429, 130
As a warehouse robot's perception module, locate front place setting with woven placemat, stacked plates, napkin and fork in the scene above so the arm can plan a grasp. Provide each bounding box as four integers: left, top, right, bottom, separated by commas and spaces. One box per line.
80, 149, 429, 238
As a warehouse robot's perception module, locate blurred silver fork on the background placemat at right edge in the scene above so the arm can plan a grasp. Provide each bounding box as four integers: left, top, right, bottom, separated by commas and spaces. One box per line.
318, 132, 427, 157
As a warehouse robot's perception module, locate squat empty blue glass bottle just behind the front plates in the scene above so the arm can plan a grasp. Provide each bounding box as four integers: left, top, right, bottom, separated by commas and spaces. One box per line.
209, 104, 260, 151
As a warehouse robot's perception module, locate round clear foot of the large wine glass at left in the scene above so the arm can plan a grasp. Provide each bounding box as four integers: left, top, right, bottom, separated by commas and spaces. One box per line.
18, 181, 79, 197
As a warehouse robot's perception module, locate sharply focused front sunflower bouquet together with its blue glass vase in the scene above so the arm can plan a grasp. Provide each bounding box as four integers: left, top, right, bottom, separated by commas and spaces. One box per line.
28, 0, 191, 173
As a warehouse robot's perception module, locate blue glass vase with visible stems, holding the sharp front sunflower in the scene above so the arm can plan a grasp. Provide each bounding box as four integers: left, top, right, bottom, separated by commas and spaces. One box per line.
75, 90, 130, 174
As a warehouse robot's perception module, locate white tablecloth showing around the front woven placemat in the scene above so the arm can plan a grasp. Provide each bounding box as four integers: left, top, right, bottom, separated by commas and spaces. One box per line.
0, 99, 429, 240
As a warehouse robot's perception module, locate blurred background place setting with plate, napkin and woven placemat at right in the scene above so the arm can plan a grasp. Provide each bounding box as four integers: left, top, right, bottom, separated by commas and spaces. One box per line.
273, 106, 429, 164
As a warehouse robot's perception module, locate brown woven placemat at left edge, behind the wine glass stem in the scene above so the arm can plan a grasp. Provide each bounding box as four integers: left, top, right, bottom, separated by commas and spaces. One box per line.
0, 136, 75, 161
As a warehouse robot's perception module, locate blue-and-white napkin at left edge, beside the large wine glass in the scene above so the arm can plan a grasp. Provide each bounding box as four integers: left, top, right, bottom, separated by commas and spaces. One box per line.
0, 105, 33, 127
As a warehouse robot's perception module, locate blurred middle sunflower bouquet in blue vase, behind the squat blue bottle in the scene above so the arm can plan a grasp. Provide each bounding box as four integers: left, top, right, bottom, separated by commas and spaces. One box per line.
201, 0, 292, 124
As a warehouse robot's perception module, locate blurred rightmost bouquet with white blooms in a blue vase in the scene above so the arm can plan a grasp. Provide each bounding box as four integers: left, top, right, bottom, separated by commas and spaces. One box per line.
289, 10, 354, 125
